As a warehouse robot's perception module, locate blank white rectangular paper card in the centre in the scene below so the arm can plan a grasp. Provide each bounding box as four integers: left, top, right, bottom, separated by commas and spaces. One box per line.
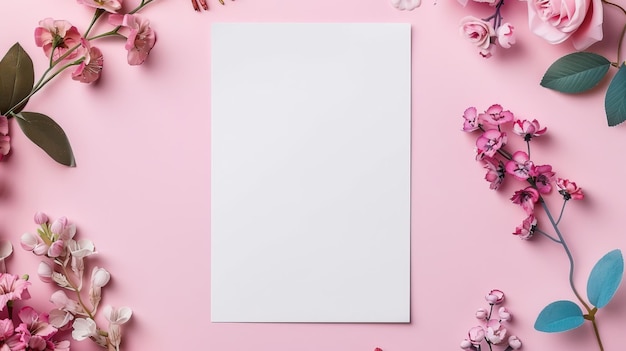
211, 23, 411, 323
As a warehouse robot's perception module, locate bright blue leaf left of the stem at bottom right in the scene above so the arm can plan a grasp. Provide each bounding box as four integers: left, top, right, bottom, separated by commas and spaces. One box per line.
535, 300, 585, 333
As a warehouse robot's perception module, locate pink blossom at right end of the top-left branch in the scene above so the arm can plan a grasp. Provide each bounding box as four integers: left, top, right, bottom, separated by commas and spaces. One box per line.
109, 14, 156, 65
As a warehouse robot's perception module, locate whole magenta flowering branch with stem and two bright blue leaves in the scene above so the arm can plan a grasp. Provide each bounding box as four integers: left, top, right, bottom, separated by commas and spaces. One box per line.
463, 104, 624, 350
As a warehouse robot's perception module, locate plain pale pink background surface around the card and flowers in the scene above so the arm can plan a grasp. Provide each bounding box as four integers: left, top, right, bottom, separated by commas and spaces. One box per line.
0, 0, 626, 351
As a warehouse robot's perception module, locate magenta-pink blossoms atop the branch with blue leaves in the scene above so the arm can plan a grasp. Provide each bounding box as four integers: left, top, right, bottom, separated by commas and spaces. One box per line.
463, 104, 584, 239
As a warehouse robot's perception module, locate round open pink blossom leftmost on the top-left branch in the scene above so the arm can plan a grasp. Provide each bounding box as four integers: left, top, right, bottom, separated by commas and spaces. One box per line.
35, 18, 81, 60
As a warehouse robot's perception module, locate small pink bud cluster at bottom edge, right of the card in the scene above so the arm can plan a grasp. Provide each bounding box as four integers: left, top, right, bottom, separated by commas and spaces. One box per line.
460, 290, 522, 351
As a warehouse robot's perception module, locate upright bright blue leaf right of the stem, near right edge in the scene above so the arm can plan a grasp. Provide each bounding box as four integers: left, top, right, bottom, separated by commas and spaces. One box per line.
587, 250, 624, 308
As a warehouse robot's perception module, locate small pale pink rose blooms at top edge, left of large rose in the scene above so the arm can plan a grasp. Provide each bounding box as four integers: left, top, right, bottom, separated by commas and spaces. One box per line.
459, 0, 515, 58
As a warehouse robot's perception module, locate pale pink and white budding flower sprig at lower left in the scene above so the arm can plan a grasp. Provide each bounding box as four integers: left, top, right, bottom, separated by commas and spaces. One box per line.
20, 212, 132, 351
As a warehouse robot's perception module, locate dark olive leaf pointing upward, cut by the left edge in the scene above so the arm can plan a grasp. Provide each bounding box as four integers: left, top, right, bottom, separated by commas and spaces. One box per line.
0, 43, 35, 115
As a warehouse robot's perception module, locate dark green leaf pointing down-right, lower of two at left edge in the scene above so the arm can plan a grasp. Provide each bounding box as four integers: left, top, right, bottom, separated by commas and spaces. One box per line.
15, 112, 76, 167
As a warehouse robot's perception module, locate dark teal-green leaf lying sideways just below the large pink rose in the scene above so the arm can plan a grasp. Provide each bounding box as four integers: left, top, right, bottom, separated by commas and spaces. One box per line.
540, 52, 611, 94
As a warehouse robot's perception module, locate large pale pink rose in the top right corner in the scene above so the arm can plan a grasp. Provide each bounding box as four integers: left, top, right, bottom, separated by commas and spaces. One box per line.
528, 0, 603, 50
